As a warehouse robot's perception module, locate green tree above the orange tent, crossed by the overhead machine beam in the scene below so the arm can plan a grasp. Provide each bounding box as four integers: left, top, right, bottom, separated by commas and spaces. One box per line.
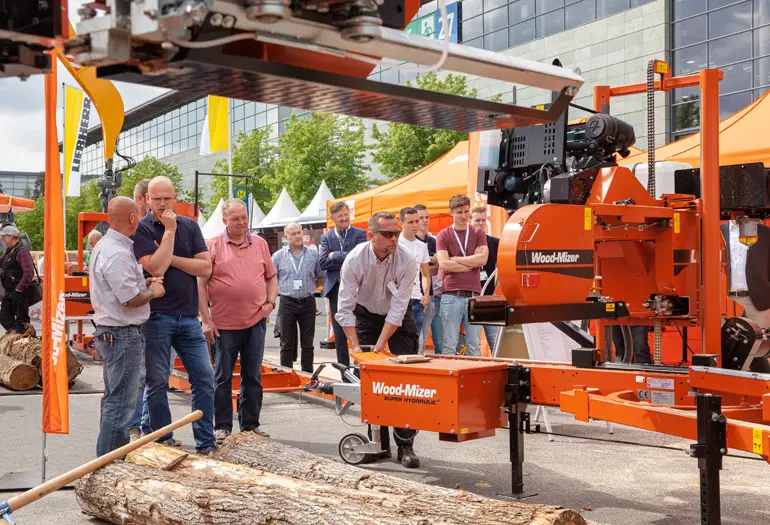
370, 72, 502, 180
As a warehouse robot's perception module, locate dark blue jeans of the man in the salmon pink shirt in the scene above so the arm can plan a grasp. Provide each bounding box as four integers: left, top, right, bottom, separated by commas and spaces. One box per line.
214, 318, 268, 432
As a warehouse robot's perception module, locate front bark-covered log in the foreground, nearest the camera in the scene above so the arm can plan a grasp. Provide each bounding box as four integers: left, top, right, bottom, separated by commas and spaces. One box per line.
76, 445, 585, 525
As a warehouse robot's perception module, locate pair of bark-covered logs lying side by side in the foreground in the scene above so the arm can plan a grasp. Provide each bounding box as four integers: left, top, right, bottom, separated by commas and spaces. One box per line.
76, 432, 586, 525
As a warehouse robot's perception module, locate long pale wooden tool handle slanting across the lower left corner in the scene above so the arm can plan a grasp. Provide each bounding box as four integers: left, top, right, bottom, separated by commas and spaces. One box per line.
0, 410, 203, 519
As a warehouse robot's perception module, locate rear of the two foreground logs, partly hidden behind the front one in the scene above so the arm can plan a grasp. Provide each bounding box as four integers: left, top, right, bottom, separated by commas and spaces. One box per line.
208, 432, 582, 523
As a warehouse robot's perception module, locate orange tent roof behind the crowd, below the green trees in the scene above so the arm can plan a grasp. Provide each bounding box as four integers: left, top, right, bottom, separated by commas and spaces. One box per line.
327, 140, 468, 224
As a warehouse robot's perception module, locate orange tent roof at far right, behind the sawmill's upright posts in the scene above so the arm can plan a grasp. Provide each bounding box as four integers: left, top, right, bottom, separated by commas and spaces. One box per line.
620, 92, 770, 168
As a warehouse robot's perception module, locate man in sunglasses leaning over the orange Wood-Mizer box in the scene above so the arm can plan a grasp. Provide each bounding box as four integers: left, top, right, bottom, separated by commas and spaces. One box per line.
337, 211, 420, 468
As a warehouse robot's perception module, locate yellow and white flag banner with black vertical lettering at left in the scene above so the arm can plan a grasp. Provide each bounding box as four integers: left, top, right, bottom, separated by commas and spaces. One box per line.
64, 86, 91, 197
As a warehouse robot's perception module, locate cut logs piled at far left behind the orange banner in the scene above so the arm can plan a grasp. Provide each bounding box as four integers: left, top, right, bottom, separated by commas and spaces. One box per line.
0, 333, 83, 390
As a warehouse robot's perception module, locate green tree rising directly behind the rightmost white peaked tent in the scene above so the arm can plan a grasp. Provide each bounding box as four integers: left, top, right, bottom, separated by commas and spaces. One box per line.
271, 113, 371, 210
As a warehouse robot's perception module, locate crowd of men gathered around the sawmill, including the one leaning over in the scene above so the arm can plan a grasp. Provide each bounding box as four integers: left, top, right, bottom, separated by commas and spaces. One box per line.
88, 177, 496, 468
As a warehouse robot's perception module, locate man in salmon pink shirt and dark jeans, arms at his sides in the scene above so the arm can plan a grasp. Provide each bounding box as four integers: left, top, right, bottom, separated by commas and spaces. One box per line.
198, 199, 278, 443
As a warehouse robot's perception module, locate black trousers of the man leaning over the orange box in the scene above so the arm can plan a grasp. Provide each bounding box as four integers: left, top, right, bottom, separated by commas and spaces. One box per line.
354, 304, 420, 450
